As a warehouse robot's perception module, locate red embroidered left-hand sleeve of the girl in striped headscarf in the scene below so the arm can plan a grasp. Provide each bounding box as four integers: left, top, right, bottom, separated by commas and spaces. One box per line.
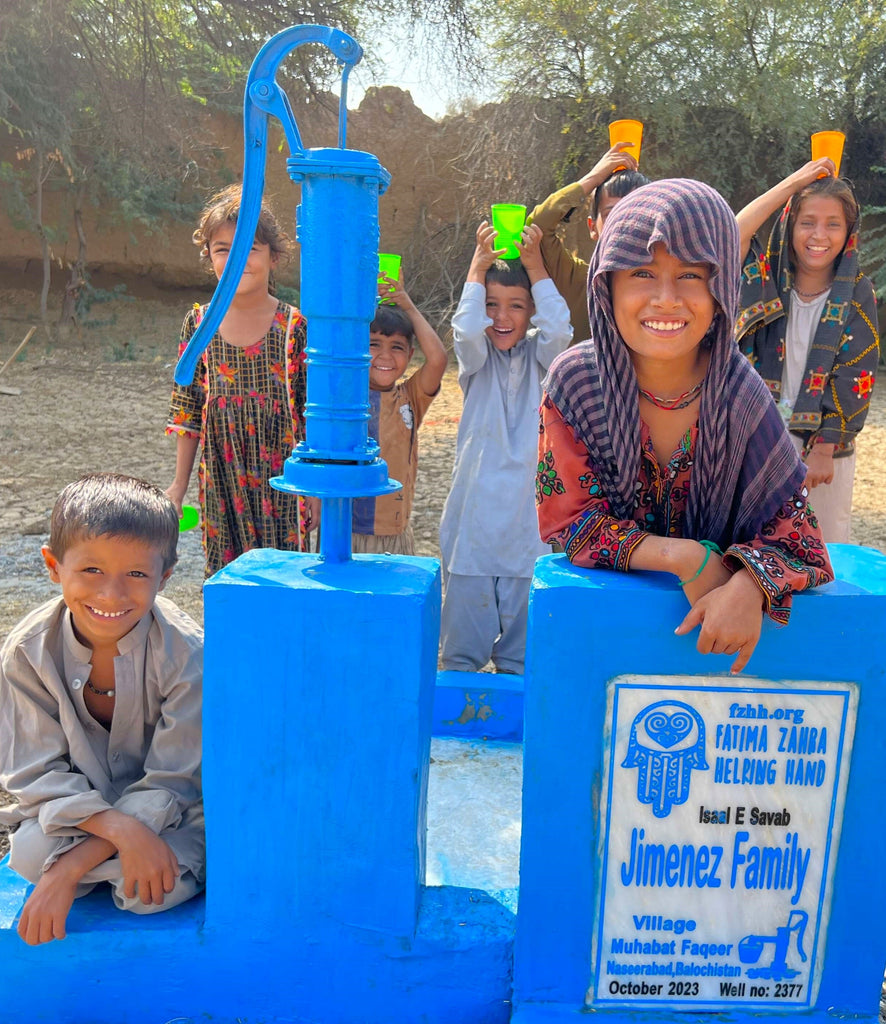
536, 394, 647, 570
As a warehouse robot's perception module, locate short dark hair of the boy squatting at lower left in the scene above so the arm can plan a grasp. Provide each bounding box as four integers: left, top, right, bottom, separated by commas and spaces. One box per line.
49, 473, 178, 572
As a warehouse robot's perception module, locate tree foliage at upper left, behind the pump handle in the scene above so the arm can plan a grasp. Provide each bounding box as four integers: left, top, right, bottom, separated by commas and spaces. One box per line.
0, 0, 477, 331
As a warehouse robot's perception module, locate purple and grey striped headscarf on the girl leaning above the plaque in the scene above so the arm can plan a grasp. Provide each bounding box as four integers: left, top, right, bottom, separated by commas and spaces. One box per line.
545, 178, 806, 548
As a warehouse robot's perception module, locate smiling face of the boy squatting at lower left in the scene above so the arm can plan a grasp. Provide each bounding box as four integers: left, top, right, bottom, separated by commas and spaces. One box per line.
42, 535, 172, 650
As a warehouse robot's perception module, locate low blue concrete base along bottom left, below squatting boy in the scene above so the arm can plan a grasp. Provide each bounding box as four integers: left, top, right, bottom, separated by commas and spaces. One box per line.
0, 864, 514, 1024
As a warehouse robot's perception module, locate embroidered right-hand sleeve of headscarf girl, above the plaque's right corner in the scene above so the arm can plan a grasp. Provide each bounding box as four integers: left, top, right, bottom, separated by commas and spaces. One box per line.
723, 487, 834, 625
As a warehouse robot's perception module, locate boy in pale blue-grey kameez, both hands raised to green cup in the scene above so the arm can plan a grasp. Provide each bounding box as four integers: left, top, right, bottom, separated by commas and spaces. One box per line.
440, 221, 573, 673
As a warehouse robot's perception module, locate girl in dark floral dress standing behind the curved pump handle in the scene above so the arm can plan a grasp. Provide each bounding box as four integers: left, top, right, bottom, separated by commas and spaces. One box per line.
166, 185, 311, 575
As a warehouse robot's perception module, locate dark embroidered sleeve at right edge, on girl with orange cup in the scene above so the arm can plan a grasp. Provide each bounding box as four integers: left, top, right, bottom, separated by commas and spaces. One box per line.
805, 274, 880, 445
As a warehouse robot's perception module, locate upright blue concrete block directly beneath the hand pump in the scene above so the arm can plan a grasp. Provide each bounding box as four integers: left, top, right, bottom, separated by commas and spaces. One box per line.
198, 550, 440, 935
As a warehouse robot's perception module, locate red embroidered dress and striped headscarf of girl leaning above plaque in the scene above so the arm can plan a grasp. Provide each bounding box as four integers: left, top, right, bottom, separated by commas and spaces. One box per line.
536, 179, 833, 623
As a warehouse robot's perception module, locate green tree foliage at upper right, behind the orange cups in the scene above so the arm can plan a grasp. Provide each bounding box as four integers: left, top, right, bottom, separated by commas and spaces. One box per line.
484, 0, 886, 206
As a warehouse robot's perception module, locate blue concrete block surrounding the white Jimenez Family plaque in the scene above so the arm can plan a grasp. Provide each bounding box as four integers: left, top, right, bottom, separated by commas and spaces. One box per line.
514, 547, 886, 1024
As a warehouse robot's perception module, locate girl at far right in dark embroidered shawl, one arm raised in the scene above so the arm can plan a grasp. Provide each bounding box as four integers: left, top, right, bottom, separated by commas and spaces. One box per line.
736, 157, 880, 544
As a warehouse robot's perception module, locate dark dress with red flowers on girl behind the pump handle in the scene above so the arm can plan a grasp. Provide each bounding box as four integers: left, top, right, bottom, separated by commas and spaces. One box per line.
166, 302, 306, 575
